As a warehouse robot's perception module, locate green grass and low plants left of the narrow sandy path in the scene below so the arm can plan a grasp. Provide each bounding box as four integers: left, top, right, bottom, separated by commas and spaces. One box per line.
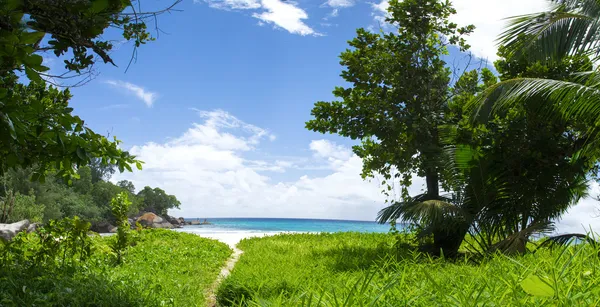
0, 227, 231, 306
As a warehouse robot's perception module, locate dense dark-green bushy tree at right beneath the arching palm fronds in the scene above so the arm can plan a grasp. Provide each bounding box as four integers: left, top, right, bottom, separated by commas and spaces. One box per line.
380, 48, 600, 254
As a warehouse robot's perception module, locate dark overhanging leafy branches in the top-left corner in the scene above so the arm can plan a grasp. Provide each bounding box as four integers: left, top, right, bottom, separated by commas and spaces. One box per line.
0, 0, 177, 81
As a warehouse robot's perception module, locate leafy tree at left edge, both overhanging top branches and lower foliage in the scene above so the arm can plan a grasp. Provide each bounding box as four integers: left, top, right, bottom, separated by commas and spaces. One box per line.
0, 0, 179, 181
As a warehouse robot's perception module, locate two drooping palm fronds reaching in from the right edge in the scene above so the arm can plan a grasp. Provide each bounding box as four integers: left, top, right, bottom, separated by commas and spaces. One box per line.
474, 0, 600, 130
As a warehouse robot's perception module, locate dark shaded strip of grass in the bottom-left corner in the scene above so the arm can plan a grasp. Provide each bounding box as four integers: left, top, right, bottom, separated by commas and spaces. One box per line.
0, 267, 160, 306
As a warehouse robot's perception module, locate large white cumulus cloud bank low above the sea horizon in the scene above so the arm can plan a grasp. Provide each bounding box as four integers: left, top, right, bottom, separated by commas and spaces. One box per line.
112, 111, 394, 220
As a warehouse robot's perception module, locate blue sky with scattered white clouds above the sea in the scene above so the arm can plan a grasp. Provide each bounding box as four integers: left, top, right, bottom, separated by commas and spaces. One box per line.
55, 0, 600, 232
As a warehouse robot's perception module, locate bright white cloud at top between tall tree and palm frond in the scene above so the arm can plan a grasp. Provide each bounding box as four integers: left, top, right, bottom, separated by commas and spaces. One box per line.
371, 0, 548, 62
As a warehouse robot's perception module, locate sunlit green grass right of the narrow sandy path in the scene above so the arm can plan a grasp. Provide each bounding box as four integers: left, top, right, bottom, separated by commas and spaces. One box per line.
218, 233, 600, 306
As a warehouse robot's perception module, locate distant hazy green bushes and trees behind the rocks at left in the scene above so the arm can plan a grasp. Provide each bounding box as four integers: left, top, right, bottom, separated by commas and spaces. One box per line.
0, 162, 180, 225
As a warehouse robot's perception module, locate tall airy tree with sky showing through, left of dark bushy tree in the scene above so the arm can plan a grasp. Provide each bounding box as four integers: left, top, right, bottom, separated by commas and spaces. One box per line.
306, 0, 473, 255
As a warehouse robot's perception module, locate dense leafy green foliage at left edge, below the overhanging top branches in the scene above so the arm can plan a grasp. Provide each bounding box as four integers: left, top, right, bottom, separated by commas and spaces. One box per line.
0, 72, 141, 182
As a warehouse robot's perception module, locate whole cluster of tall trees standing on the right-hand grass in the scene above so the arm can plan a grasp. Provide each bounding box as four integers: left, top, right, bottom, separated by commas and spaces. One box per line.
307, 0, 600, 256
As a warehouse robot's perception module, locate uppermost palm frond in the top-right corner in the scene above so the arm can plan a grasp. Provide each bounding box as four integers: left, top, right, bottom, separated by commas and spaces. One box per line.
499, 0, 600, 60
